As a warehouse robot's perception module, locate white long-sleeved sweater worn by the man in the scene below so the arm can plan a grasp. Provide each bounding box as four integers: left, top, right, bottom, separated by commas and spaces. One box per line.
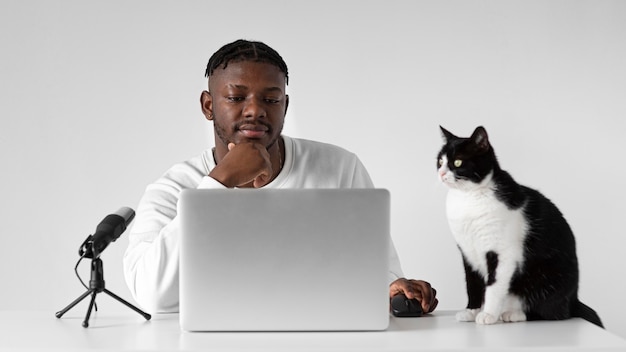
124, 136, 403, 313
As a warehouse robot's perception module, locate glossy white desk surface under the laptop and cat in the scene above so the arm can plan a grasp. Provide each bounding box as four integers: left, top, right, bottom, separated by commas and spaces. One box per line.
0, 311, 626, 352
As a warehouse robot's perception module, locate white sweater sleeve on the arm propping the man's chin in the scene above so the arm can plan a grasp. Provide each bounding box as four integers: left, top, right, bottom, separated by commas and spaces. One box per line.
123, 155, 224, 313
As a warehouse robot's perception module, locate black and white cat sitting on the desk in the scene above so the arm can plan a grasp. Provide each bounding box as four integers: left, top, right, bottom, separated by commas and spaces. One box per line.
437, 127, 602, 326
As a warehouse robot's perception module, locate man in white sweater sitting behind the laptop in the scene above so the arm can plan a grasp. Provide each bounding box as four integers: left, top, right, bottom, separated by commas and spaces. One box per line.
124, 40, 438, 312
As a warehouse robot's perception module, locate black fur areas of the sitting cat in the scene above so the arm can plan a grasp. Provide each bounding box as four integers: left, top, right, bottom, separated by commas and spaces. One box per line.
437, 127, 603, 327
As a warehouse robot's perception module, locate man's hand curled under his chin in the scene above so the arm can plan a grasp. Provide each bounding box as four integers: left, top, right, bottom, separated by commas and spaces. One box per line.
209, 143, 272, 188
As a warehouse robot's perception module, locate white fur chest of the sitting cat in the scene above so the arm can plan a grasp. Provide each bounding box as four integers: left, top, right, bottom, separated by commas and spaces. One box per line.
446, 188, 526, 275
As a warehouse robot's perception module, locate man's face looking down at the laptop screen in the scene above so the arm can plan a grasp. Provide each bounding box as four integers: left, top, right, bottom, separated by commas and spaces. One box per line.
202, 61, 289, 151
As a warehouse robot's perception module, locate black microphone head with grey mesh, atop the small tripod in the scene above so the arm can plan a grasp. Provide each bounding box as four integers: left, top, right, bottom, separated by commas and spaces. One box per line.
78, 207, 135, 259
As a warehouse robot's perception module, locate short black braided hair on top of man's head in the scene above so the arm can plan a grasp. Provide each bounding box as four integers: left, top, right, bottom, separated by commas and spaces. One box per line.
204, 39, 289, 83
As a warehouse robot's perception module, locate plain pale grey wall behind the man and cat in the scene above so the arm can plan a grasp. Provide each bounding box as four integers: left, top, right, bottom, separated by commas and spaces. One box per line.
0, 0, 626, 337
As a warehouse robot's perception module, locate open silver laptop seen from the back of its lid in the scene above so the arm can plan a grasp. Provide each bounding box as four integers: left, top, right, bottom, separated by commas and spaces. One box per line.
178, 189, 390, 331
